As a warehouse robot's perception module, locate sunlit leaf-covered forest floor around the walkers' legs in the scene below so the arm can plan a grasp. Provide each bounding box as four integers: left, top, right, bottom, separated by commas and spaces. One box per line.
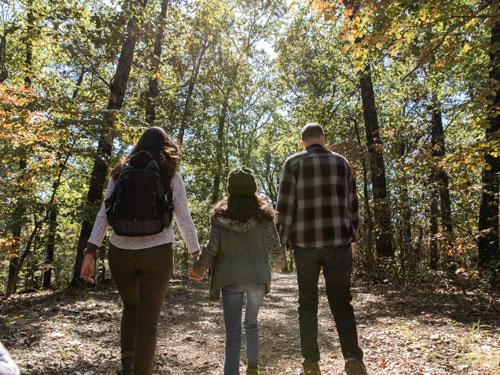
0, 274, 500, 375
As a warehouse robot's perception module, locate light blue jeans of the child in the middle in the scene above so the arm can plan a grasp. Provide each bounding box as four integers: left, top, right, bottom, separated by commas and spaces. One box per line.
222, 283, 266, 375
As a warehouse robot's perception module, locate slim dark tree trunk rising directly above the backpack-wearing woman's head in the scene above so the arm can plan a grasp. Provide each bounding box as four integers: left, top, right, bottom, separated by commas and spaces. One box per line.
146, 0, 168, 126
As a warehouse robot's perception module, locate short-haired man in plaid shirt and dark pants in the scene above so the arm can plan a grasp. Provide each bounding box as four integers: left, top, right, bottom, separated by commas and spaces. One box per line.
278, 123, 366, 375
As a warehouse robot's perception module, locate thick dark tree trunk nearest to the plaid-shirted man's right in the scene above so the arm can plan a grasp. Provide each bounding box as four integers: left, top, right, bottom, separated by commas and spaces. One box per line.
360, 66, 394, 257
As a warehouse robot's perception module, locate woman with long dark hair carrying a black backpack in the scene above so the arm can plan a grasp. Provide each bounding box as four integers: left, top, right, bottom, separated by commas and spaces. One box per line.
81, 127, 200, 375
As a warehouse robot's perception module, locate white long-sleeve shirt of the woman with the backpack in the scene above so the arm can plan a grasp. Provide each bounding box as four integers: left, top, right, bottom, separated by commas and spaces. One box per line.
88, 173, 200, 253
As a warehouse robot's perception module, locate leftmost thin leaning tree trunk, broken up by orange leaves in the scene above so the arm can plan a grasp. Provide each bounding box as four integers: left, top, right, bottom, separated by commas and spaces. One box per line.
5, 8, 35, 296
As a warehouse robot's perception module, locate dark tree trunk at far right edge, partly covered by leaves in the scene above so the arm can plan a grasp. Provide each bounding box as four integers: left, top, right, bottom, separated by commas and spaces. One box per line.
478, 15, 500, 269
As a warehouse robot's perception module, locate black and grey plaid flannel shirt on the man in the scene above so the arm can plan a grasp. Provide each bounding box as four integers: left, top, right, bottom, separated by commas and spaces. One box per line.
278, 144, 358, 248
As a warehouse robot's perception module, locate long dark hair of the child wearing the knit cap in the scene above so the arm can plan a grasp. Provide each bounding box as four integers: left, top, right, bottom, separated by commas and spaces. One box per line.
210, 194, 278, 222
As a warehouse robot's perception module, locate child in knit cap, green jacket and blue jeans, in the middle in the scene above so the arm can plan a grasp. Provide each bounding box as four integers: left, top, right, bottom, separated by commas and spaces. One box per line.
190, 168, 286, 375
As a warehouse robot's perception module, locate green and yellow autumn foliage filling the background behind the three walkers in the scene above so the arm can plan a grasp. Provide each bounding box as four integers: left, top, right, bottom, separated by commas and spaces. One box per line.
0, 0, 500, 294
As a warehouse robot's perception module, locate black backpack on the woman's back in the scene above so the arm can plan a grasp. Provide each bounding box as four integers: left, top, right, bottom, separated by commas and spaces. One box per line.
104, 151, 174, 237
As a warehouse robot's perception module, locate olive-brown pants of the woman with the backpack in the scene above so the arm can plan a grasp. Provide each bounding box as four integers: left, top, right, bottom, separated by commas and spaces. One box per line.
108, 243, 173, 375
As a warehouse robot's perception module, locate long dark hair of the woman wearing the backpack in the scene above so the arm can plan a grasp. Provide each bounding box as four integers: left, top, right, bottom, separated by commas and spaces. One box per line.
111, 127, 181, 182
